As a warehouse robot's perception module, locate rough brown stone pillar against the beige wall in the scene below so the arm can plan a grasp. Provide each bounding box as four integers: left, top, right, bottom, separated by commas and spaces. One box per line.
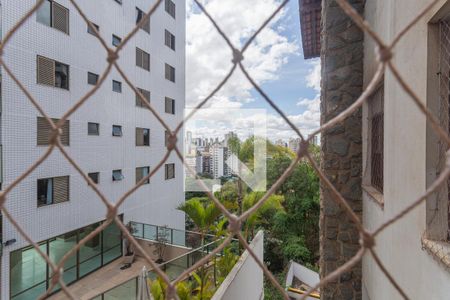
320, 0, 364, 300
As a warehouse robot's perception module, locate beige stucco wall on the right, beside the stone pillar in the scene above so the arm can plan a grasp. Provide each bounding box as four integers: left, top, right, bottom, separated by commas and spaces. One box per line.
363, 0, 450, 300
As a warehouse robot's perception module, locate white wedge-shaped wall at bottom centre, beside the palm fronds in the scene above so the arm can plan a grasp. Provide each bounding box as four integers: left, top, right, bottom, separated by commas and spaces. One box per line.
212, 231, 264, 300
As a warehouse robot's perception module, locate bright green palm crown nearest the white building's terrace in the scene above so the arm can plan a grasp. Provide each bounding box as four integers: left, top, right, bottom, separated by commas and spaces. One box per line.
178, 198, 221, 246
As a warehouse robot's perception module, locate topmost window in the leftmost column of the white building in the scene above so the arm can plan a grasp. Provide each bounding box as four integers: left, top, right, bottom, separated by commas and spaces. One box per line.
36, 0, 69, 34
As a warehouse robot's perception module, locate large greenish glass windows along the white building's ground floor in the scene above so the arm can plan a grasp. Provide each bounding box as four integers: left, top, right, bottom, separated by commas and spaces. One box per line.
9, 219, 123, 300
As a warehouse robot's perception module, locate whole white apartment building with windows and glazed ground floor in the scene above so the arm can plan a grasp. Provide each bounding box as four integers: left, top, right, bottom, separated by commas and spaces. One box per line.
0, 0, 185, 299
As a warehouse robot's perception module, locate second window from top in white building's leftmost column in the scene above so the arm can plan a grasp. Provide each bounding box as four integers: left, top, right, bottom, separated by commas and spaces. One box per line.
37, 55, 69, 90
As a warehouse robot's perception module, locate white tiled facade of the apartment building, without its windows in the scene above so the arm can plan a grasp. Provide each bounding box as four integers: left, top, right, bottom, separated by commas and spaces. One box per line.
1, 0, 185, 299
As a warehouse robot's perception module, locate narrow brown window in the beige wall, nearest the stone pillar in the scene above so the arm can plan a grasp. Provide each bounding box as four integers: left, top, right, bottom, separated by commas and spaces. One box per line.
368, 84, 384, 193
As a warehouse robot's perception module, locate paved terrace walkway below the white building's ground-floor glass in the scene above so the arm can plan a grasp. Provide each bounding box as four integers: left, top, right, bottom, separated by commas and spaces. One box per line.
48, 257, 150, 300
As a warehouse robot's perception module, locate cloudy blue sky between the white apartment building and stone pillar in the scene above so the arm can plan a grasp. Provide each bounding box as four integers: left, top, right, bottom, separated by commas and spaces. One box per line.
186, 0, 320, 140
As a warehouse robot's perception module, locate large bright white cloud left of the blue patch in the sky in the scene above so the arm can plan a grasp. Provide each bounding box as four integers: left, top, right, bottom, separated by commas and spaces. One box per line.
186, 0, 298, 107
